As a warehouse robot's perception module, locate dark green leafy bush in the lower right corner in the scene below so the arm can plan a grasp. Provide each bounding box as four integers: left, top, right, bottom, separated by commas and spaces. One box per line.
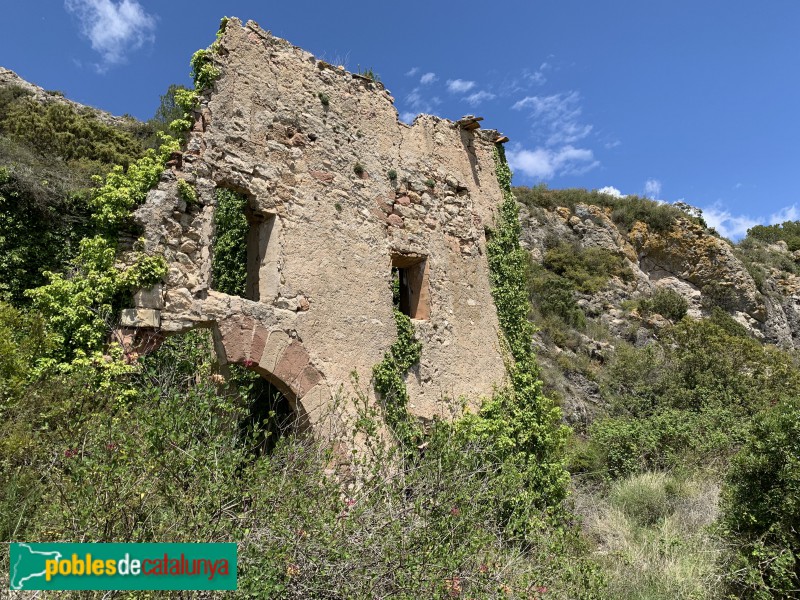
721, 397, 800, 599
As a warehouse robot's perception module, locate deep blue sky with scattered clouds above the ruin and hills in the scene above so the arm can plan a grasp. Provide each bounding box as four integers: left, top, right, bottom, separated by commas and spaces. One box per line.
0, 0, 800, 238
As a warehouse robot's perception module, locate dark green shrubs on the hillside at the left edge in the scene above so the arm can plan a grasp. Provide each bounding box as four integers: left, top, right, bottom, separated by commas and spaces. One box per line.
0, 88, 157, 305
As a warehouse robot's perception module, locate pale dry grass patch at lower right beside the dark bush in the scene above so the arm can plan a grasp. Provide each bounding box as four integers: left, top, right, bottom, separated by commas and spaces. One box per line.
575, 473, 723, 600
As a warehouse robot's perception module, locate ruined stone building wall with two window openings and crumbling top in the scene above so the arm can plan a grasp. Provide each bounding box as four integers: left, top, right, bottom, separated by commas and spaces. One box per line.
124, 19, 505, 432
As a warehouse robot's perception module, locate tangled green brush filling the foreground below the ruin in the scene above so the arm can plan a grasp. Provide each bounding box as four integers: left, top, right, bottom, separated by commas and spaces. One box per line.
0, 331, 601, 600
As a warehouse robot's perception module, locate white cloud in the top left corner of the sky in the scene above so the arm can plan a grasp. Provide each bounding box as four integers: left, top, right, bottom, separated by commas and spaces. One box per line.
64, 0, 156, 71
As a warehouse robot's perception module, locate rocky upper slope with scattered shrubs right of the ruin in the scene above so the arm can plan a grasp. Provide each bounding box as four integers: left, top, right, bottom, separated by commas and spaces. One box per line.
516, 187, 800, 424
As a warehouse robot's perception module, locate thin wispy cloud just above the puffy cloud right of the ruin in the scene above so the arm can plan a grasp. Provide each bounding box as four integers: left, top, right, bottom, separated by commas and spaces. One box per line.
511, 92, 592, 146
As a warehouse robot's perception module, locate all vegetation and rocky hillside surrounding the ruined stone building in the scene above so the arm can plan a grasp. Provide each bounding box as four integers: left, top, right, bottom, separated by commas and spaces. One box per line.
0, 54, 800, 599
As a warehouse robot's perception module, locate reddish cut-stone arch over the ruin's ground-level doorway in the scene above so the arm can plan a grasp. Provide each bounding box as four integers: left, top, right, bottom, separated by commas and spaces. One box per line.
214, 315, 331, 429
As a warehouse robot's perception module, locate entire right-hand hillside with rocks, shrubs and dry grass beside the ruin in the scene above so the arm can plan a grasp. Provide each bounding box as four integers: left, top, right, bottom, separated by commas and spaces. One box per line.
515, 186, 800, 598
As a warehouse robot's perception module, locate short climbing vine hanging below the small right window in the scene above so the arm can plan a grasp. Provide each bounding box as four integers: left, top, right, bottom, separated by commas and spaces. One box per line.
372, 308, 422, 446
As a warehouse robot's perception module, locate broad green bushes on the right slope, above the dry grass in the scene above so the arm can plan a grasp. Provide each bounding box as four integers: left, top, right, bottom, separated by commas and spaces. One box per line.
589, 318, 800, 477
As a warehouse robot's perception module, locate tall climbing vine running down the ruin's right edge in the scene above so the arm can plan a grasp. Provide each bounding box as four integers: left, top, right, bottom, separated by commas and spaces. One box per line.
457, 146, 569, 534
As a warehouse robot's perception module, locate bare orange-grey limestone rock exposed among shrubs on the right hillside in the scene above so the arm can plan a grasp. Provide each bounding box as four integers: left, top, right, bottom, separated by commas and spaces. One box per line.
520, 202, 800, 427
